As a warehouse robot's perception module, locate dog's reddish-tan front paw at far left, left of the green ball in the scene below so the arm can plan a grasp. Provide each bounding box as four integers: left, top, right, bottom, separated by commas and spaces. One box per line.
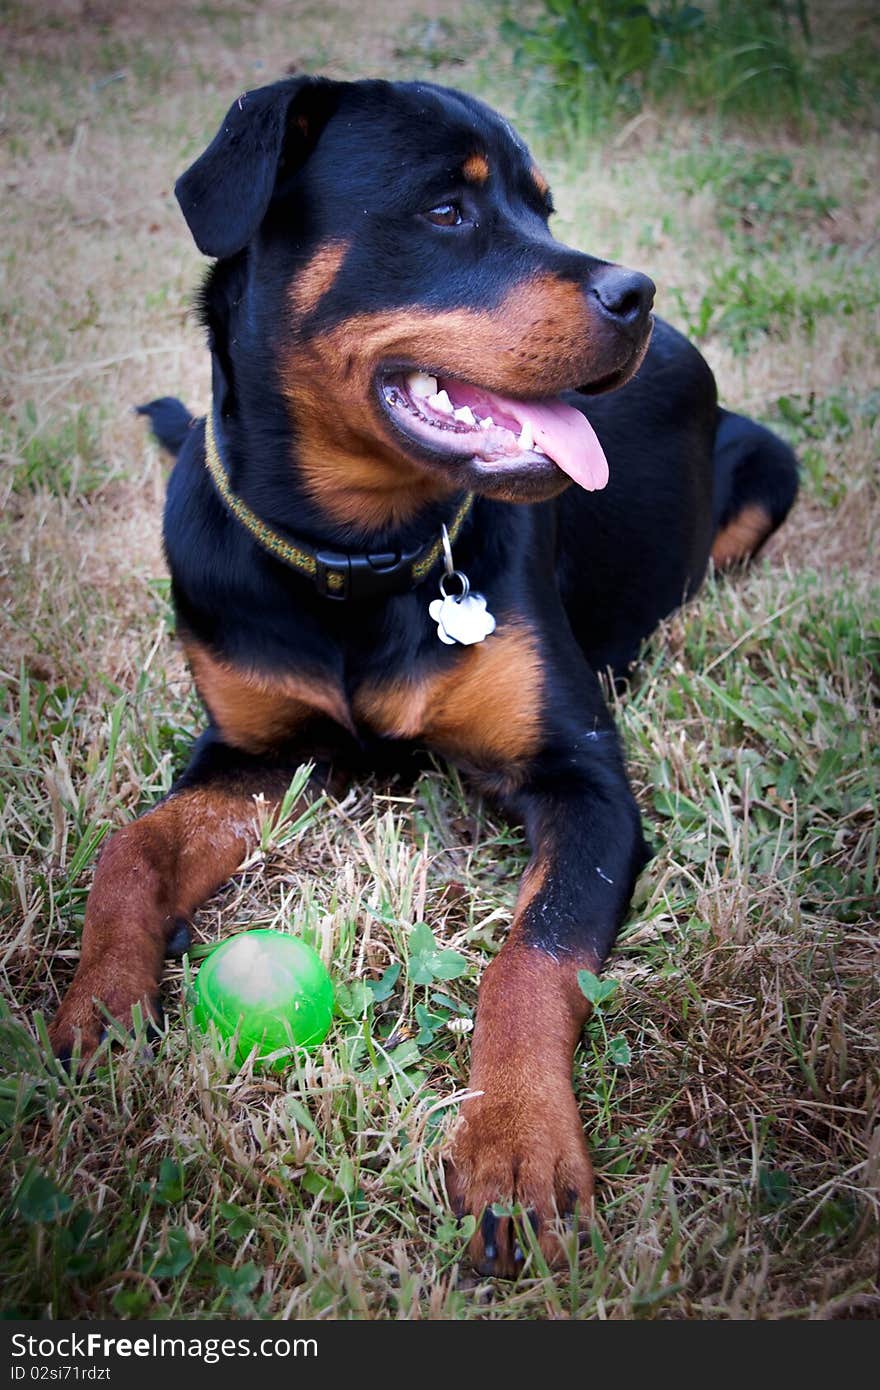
49, 956, 161, 1062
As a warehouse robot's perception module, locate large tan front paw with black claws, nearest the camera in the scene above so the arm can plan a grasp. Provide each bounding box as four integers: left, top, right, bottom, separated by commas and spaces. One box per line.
446, 1086, 592, 1279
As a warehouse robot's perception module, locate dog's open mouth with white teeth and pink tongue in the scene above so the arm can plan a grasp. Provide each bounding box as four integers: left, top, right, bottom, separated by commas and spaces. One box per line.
378, 370, 608, 492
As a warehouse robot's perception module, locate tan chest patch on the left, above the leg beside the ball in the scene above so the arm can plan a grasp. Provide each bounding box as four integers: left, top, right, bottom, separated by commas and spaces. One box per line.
184, 639, 352, 753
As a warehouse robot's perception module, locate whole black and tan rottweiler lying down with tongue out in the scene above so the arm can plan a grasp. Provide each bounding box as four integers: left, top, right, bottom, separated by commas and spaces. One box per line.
51, 76, 797, 1275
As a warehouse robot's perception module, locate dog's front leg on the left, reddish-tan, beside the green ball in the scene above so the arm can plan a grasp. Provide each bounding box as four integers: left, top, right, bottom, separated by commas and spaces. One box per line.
49, 731, 315, 1058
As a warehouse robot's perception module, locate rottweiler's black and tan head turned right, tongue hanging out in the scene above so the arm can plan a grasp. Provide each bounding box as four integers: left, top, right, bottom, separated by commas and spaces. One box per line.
177, 78, 653, 525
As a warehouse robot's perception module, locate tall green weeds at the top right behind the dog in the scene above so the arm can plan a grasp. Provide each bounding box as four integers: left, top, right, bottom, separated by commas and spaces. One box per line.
499, 0, 876, 139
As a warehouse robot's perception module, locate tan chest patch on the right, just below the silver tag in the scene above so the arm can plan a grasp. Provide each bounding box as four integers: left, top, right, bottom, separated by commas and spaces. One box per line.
353, 623, 544, 771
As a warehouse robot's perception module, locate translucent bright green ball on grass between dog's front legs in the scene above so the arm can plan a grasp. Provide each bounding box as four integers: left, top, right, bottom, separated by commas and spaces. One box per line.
193, 930, 334, 1070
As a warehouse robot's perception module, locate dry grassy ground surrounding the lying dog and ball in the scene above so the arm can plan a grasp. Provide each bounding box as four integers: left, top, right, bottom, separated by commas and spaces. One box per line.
0, 0, 880, 1319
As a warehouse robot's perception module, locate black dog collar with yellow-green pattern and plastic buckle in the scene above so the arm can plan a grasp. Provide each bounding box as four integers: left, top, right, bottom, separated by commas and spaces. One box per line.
204, 410, 474, 599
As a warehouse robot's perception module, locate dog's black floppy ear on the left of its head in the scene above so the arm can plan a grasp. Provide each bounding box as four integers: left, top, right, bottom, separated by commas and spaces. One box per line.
174, 78, 343, 259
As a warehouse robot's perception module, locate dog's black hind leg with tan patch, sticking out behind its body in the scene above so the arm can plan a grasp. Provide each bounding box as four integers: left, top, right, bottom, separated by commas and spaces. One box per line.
712, 410, 798, 569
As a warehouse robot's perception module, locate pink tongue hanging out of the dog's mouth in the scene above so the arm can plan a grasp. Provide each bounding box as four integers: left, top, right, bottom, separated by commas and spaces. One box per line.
443, 381, 608, 492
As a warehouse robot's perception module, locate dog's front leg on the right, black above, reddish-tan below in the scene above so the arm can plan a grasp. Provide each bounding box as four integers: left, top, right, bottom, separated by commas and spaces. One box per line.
446, 728, 645, 1276
